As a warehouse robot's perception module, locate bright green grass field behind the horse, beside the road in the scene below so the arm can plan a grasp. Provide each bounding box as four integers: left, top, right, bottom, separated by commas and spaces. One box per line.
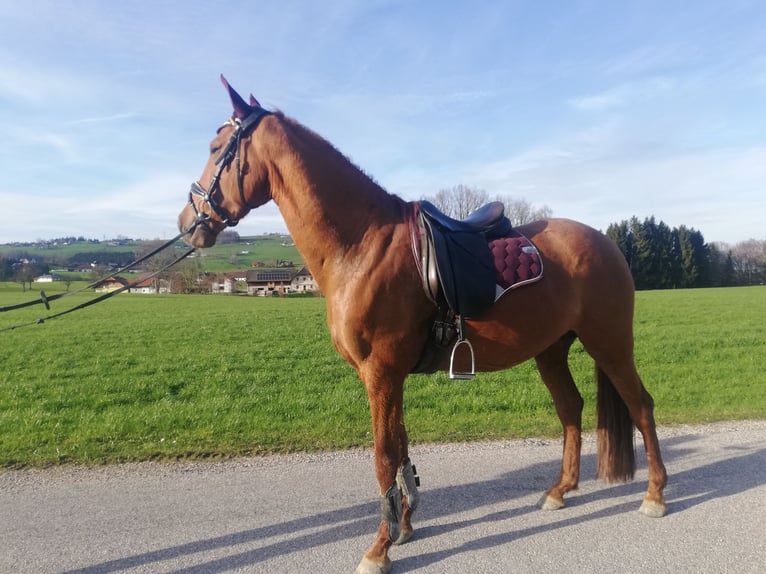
0, 284, 766, 468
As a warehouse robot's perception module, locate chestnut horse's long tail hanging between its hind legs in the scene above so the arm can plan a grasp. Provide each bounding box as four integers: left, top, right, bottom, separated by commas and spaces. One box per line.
596, 366, 636, 482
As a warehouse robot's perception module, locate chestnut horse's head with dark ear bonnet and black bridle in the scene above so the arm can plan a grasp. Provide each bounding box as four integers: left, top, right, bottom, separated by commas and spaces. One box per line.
178, 76, 271, 247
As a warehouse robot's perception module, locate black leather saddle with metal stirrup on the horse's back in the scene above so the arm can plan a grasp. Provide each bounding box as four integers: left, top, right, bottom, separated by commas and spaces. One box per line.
412, 201, 512, 379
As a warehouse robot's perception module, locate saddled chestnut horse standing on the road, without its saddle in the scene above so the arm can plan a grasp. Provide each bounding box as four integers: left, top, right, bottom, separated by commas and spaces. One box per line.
179, 77, 667, 574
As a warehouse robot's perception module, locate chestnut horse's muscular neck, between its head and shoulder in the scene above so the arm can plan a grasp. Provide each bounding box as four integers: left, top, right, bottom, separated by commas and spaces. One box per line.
270, 119, 405, 286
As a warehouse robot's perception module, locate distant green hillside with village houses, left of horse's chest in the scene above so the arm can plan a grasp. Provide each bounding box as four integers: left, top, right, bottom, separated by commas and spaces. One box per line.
0, 231, 320, 297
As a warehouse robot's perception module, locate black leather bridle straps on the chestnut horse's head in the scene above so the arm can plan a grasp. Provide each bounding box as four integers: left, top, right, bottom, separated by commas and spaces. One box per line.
189, 107, 271, 233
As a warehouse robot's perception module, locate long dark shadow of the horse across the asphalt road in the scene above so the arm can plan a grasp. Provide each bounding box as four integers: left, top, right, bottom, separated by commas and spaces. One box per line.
66, 435, 766, 574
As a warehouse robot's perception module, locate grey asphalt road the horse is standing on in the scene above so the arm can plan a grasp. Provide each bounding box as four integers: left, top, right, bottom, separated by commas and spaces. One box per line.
0, 421, 766, 574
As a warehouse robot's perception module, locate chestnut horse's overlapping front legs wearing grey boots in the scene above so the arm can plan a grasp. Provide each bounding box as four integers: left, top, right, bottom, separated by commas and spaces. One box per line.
356, 377, 418, 574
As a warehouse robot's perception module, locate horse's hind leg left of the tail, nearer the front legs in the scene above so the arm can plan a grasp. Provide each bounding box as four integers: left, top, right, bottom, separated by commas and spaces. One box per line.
535, 333, 583, 510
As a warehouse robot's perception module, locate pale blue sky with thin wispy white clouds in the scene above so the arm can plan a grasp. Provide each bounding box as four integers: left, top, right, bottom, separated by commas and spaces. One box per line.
0, 0, 766, 243
